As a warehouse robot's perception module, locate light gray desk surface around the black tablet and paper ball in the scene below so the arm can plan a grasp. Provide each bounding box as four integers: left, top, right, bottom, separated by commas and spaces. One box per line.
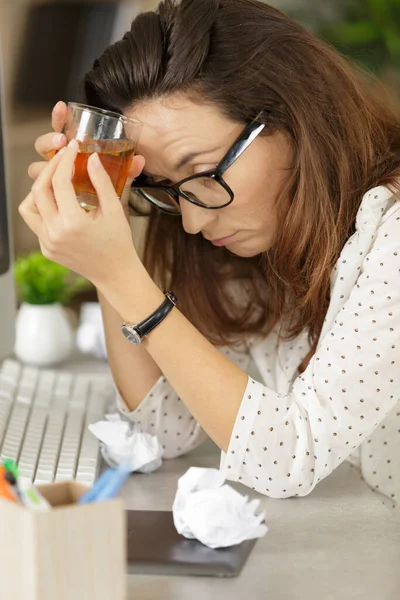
67, 359, 400, 600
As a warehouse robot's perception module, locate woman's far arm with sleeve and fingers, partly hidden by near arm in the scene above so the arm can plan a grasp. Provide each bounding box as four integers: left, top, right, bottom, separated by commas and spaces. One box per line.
28, 102, 206, 458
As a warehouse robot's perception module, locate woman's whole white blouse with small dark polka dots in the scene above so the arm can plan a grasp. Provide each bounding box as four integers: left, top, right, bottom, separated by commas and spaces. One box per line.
118, 187, 400, 508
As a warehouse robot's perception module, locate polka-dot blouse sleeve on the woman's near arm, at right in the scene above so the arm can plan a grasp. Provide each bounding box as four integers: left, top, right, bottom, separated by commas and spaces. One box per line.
221, 204, 400, 498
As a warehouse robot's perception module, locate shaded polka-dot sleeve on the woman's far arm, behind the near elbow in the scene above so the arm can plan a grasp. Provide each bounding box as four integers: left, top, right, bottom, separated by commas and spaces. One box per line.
117, 347, 249, 459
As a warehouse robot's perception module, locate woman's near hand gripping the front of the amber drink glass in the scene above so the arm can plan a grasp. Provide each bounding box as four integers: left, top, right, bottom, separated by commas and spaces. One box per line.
19, 140, 143, 290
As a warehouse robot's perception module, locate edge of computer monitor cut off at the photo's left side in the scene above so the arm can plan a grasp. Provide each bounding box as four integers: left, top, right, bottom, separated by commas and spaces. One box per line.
0, 48, 15, 360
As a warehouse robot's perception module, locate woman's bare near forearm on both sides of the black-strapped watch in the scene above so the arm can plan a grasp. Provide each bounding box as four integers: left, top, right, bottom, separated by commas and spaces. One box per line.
100, 261, 247, 448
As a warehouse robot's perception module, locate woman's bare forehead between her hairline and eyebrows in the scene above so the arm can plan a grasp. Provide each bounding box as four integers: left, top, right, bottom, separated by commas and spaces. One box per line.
125, 95, 241, 155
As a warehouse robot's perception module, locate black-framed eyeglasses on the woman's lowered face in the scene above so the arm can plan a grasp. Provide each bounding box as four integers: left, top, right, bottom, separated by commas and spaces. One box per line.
132, 112, 265, 215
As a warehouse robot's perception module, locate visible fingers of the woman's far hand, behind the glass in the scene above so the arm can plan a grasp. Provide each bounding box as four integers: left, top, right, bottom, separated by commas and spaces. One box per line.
28, 102, 144, 218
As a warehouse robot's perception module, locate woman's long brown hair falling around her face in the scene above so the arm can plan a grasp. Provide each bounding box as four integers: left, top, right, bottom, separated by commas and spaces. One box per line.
85, 0, 400, 344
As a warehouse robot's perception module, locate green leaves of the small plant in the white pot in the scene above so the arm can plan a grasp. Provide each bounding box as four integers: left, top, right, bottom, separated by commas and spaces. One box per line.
14, 252, 87, 304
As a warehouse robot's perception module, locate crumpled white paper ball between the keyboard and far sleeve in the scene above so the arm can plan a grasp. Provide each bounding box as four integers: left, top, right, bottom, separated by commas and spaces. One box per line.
89, 413, 163, 473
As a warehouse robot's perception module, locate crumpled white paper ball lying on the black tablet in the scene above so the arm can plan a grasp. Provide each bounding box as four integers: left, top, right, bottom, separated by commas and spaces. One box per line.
172, 467, 268, 548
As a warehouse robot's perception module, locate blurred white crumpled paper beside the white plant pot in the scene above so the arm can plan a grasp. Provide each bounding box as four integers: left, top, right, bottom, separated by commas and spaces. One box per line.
76, 302, 107, 358
